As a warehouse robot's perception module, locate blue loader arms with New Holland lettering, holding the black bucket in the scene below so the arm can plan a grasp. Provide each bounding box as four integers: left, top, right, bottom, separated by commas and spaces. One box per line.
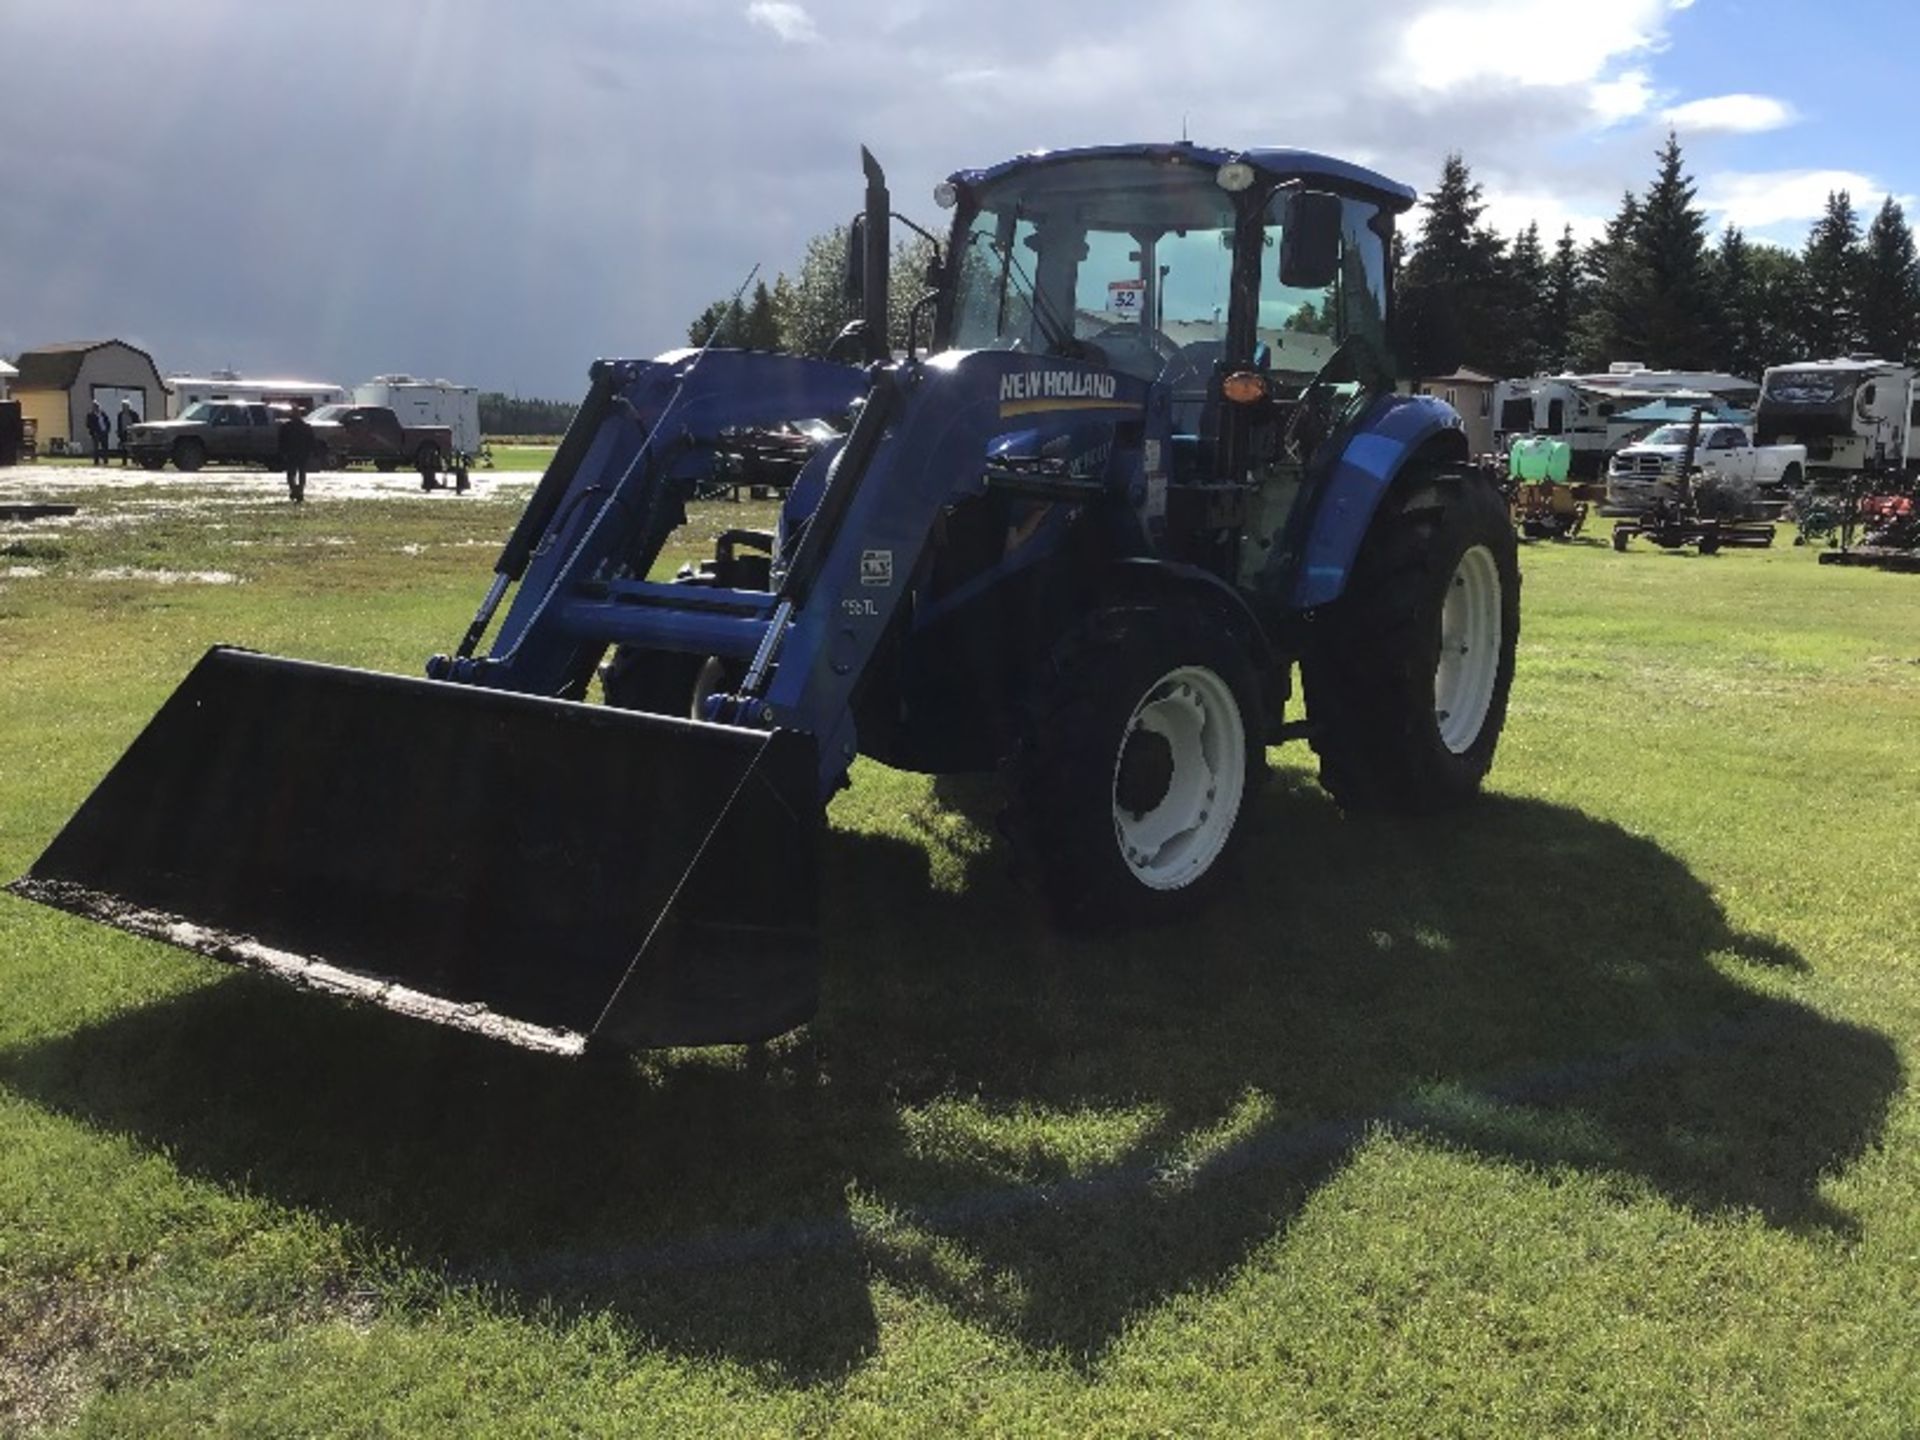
441, 351, 1148, 804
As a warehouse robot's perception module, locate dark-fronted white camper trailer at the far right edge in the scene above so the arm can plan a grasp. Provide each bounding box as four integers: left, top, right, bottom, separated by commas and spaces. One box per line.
1759, 355, 1920, 484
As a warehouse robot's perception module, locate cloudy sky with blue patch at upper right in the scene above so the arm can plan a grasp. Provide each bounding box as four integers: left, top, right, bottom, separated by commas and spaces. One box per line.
0, 0, 1920, 399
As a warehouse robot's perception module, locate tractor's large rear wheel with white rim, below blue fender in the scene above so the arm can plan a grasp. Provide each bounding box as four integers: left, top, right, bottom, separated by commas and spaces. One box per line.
1300, 474, 1521, 814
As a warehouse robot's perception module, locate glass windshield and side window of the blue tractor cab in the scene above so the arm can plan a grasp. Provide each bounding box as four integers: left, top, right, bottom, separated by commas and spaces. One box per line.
950, 156, 1386, 380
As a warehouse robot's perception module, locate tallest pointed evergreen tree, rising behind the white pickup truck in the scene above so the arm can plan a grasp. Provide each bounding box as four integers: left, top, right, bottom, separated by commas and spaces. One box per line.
1619, 132, 1716, 371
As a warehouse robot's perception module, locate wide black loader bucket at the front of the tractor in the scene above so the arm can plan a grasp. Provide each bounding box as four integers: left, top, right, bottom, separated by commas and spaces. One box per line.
10, 649, 820, 1054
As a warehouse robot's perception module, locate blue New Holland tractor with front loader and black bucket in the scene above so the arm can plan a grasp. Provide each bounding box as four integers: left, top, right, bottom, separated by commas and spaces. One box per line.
13, 142, 1519, 1054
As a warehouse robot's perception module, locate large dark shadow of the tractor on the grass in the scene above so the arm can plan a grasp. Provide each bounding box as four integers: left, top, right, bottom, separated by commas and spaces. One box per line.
0, 781, 1901, 1382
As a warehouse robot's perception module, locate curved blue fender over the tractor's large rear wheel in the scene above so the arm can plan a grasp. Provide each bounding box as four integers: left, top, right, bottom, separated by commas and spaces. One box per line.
1292, 396, 1467, 611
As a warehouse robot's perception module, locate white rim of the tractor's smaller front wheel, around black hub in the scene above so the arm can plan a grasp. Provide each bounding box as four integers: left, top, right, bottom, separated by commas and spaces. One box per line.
1112, 666, 1246, 891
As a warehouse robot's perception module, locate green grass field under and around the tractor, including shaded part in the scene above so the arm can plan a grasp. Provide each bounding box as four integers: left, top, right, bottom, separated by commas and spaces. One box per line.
0, 482, 1920, 1436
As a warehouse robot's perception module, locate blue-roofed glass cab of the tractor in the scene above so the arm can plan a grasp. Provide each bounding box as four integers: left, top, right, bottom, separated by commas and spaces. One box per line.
935, 144, 1413, 484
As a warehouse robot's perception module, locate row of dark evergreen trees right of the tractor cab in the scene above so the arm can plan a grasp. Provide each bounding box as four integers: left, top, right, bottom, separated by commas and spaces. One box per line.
1396, 134, 1920, 378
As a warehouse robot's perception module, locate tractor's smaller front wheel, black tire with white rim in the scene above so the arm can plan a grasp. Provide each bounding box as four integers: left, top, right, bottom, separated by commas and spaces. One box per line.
1008, 603, 1265, 929
